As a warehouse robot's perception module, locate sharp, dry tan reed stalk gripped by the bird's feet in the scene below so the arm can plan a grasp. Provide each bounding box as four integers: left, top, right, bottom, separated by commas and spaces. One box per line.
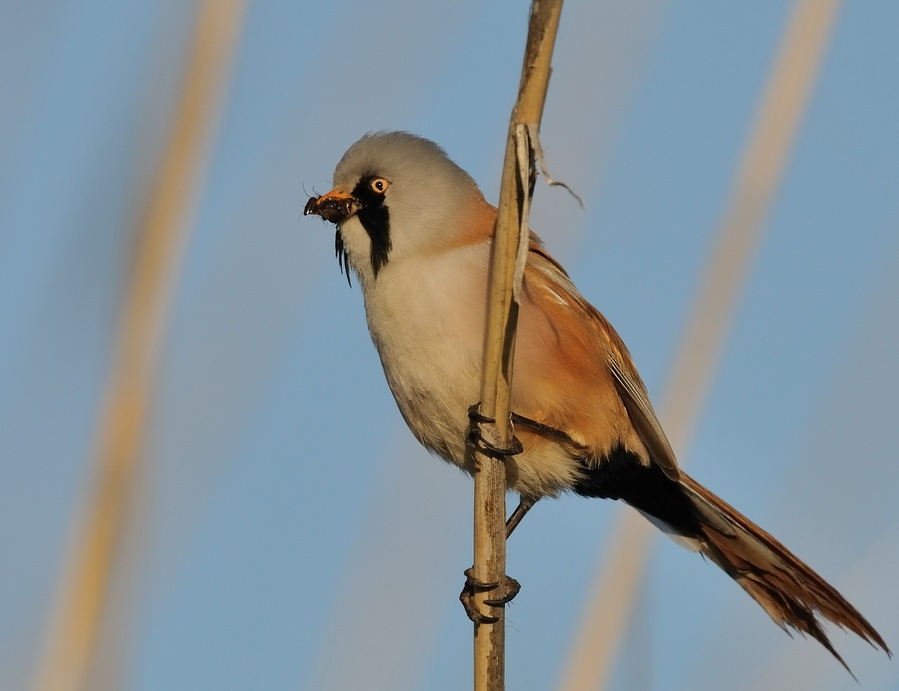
473, 0, 562, 691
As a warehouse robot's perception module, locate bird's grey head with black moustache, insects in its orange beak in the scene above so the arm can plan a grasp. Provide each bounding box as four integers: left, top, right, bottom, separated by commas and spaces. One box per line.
305, 132, 484, 281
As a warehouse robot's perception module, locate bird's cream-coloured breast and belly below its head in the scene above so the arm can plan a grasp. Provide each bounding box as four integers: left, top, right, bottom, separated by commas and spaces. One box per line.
366, 254, 583, 498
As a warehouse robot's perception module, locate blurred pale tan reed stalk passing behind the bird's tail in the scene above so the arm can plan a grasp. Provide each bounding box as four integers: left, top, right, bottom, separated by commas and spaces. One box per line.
559, 0, 840, 691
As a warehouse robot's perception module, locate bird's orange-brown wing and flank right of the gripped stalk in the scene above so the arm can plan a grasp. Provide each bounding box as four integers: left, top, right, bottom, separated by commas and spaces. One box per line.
513, 235, 680, 479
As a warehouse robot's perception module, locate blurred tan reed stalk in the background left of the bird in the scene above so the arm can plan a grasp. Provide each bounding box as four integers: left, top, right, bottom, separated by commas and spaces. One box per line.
33, 0, 244, 691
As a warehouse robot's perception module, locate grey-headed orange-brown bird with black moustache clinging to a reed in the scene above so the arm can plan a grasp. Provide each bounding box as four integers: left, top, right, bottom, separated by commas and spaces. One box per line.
304, 131, 891, 674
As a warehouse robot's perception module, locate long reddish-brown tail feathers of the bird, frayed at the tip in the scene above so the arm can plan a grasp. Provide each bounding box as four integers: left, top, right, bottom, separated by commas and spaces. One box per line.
664, 472, 892, 674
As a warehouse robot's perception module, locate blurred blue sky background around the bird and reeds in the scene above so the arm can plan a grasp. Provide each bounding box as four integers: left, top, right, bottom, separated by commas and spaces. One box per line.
0, 0, 899, 691
